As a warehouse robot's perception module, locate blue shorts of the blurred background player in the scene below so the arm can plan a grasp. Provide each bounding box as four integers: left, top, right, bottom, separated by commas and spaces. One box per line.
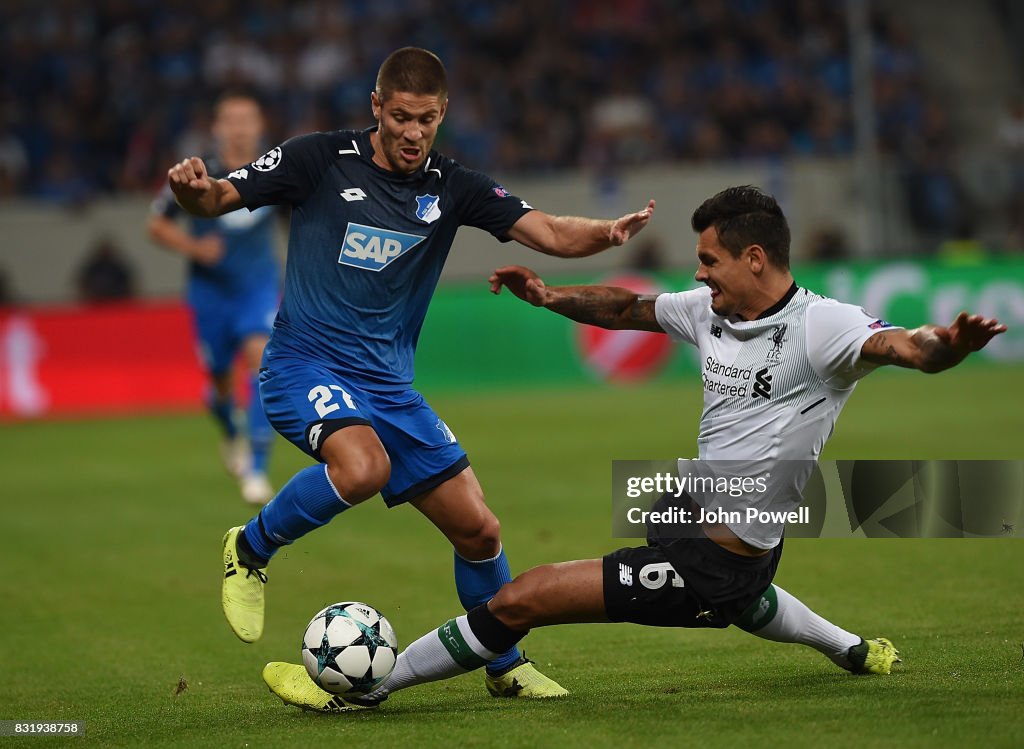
188, 285, 279, 375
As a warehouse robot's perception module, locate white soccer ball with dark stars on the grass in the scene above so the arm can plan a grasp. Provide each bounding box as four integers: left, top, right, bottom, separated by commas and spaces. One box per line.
302, 600, 398, 695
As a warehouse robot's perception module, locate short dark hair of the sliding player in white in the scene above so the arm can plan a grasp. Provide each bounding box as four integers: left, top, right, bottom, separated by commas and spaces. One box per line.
690, 184, 790, 269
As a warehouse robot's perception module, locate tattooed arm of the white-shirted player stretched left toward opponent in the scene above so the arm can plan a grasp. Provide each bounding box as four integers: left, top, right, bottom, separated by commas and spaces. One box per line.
489, 265, 665, 333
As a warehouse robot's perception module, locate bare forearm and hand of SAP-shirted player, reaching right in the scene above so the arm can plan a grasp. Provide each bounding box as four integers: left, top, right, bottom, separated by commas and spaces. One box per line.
509, 201, 654, 257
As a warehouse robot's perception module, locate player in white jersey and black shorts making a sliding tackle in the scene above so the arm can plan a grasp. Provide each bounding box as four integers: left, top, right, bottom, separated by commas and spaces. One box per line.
264, 186, 1007, 711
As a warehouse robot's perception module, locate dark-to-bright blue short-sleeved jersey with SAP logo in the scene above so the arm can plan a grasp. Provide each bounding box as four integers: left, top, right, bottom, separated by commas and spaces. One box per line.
227, 129, 531, 390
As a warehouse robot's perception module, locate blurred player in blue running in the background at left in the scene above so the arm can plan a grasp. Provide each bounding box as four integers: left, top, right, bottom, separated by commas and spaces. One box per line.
148, 91, 281, 504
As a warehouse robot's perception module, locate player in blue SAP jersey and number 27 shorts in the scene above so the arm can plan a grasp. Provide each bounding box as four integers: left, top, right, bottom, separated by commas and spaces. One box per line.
168, 47, 654, 698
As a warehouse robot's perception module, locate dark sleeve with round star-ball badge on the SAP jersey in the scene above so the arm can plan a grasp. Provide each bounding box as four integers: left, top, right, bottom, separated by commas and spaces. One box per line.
225, 132, 335, 210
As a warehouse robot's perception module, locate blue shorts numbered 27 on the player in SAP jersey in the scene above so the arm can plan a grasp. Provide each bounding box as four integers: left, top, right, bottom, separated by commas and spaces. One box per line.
259, 358, 469, 507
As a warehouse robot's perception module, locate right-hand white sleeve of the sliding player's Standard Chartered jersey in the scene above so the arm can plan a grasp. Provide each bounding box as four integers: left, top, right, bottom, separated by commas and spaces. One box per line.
807, 299, 897, 390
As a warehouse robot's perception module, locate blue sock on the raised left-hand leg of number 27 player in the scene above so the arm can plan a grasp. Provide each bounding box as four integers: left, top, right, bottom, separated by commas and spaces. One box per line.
245, 464, 350, 565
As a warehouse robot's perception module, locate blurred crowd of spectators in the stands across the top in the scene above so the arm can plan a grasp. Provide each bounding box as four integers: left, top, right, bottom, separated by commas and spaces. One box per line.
0, 0, 930, 193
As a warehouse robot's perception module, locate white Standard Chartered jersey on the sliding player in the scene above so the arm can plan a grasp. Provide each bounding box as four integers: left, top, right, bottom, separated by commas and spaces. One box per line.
654, 286, 893, 549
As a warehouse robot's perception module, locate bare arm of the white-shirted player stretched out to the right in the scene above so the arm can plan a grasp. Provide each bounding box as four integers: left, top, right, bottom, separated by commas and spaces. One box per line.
860, 313, 1007, 373
